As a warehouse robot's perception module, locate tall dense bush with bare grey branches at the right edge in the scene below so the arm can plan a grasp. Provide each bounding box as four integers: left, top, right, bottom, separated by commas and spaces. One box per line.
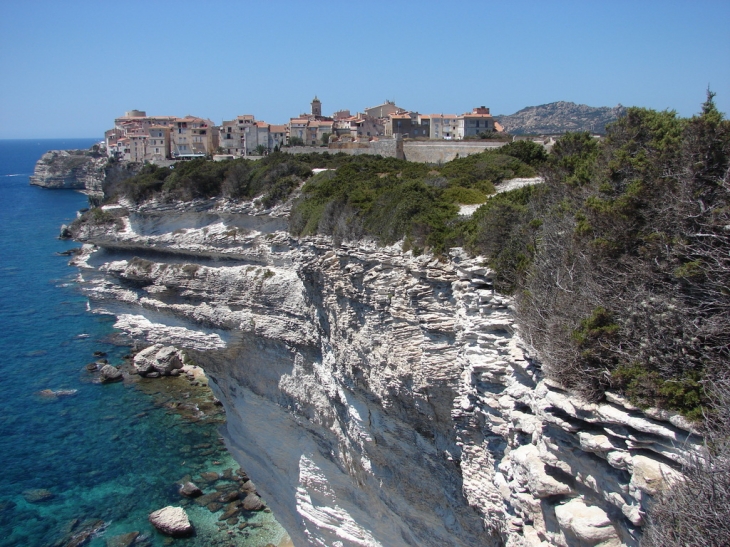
512, 93, 730, 419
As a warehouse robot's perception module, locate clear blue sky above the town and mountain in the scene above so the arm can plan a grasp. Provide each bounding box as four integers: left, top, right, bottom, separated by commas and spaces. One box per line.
0, 0, 730, 138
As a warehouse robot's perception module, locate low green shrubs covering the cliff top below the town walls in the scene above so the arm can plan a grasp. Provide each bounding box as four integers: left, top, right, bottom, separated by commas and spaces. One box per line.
105, 141, 546, 253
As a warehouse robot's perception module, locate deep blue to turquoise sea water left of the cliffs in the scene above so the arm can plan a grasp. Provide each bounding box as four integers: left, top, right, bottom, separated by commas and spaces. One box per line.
0, 139, 286, 547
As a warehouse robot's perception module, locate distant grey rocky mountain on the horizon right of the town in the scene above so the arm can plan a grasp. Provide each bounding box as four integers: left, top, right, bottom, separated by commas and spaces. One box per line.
494, 101, 626, 135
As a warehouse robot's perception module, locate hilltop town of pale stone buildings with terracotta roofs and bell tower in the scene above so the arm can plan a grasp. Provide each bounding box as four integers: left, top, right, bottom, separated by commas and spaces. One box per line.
104, 96, 503, 163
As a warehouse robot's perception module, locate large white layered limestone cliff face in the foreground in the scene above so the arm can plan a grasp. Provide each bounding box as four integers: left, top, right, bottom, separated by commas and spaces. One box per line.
69, 202, 700, 547
